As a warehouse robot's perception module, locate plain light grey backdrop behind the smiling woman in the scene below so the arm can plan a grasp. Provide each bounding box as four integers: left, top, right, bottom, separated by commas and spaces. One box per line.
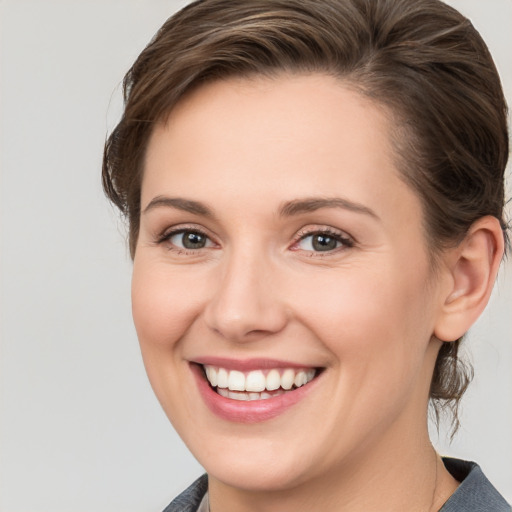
0, 0, 512, 512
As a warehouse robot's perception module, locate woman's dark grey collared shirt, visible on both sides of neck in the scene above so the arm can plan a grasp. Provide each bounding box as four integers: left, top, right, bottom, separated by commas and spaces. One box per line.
163, 458, 512, 512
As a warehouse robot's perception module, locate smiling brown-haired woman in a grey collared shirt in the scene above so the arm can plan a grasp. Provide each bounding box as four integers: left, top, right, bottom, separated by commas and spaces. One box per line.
103, 0, 510, 512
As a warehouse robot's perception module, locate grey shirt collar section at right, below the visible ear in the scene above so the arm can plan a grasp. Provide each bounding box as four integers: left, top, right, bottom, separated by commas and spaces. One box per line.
440, 458, 512, 512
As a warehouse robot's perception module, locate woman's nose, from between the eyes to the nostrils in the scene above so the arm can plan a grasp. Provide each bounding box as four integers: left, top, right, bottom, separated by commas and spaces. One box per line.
204, 247, 288, 342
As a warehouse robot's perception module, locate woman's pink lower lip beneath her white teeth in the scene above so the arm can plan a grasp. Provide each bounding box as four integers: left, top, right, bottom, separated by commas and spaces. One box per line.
190, 364, 318, 423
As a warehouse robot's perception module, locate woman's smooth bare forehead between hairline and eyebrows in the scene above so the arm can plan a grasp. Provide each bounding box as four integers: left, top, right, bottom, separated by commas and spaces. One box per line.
142, 74, 417, 228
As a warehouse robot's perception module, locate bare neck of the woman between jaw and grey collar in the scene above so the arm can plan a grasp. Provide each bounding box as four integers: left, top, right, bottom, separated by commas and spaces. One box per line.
209, 426, 458, 512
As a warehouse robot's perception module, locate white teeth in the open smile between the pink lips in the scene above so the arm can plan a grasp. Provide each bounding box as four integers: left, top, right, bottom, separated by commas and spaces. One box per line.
202, 365, 320, 401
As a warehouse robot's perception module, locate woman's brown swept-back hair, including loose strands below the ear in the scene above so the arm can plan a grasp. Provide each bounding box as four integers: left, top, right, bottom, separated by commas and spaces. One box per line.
103, 0, 509, 430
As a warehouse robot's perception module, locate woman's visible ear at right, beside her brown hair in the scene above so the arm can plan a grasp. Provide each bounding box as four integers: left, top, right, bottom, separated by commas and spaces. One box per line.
434, 216, 504, 341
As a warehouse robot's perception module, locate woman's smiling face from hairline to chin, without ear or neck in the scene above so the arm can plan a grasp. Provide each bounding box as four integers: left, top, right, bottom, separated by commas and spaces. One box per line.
132, 75, 448, 490
